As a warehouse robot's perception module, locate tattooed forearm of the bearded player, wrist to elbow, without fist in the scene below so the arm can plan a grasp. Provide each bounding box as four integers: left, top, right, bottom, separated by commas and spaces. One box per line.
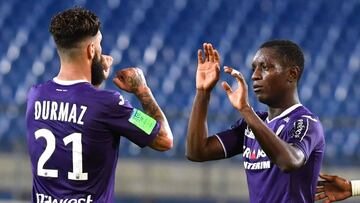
135, 87, 173, 151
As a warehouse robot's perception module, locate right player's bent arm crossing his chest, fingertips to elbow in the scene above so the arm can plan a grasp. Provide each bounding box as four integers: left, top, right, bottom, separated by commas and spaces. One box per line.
222, 67, 305, 172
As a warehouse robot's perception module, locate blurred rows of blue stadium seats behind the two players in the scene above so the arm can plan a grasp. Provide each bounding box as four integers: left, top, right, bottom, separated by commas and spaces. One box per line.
0, 0, 360, 164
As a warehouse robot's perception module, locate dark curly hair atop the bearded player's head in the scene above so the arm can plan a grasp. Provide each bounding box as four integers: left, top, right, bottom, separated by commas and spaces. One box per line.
49, 7, 100, 49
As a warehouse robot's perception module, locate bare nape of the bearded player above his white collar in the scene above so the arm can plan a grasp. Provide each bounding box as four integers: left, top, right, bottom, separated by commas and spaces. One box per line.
57, 59, 91, 82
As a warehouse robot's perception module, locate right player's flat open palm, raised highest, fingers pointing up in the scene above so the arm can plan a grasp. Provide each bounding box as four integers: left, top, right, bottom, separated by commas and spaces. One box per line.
196, 43, 220, 91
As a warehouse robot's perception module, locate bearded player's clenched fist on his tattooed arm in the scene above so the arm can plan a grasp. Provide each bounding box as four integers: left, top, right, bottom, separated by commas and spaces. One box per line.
113, 67, 148, 94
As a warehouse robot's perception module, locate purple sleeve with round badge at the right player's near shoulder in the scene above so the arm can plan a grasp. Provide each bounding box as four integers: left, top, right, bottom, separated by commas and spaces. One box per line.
288, 116, 325, 160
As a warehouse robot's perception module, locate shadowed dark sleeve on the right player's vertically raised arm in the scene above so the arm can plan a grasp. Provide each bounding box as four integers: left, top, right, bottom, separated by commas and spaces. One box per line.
215, 119, 247, 158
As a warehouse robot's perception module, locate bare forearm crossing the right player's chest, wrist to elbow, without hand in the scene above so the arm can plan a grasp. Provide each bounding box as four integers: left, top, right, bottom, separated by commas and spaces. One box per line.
240, 107, 304, 172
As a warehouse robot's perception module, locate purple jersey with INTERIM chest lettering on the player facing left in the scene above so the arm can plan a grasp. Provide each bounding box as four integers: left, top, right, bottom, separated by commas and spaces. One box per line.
216, 104, 325, 203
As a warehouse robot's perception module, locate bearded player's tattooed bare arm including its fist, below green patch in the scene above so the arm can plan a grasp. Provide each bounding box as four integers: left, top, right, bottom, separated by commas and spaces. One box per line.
113, 68, 173, 151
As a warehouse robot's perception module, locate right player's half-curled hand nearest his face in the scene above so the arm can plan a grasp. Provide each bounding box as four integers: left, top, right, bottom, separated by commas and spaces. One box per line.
222, 66, 250, 111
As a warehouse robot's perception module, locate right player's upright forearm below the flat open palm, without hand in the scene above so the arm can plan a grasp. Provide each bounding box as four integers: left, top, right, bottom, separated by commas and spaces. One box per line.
186, 90, 210, 161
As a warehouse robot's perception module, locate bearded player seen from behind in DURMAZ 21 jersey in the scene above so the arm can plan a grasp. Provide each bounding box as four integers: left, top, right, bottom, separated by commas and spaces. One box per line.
26, 7, 173, 203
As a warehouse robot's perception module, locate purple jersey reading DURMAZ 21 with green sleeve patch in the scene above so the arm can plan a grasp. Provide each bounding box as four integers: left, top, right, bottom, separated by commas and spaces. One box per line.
26, 79, 160, 203
